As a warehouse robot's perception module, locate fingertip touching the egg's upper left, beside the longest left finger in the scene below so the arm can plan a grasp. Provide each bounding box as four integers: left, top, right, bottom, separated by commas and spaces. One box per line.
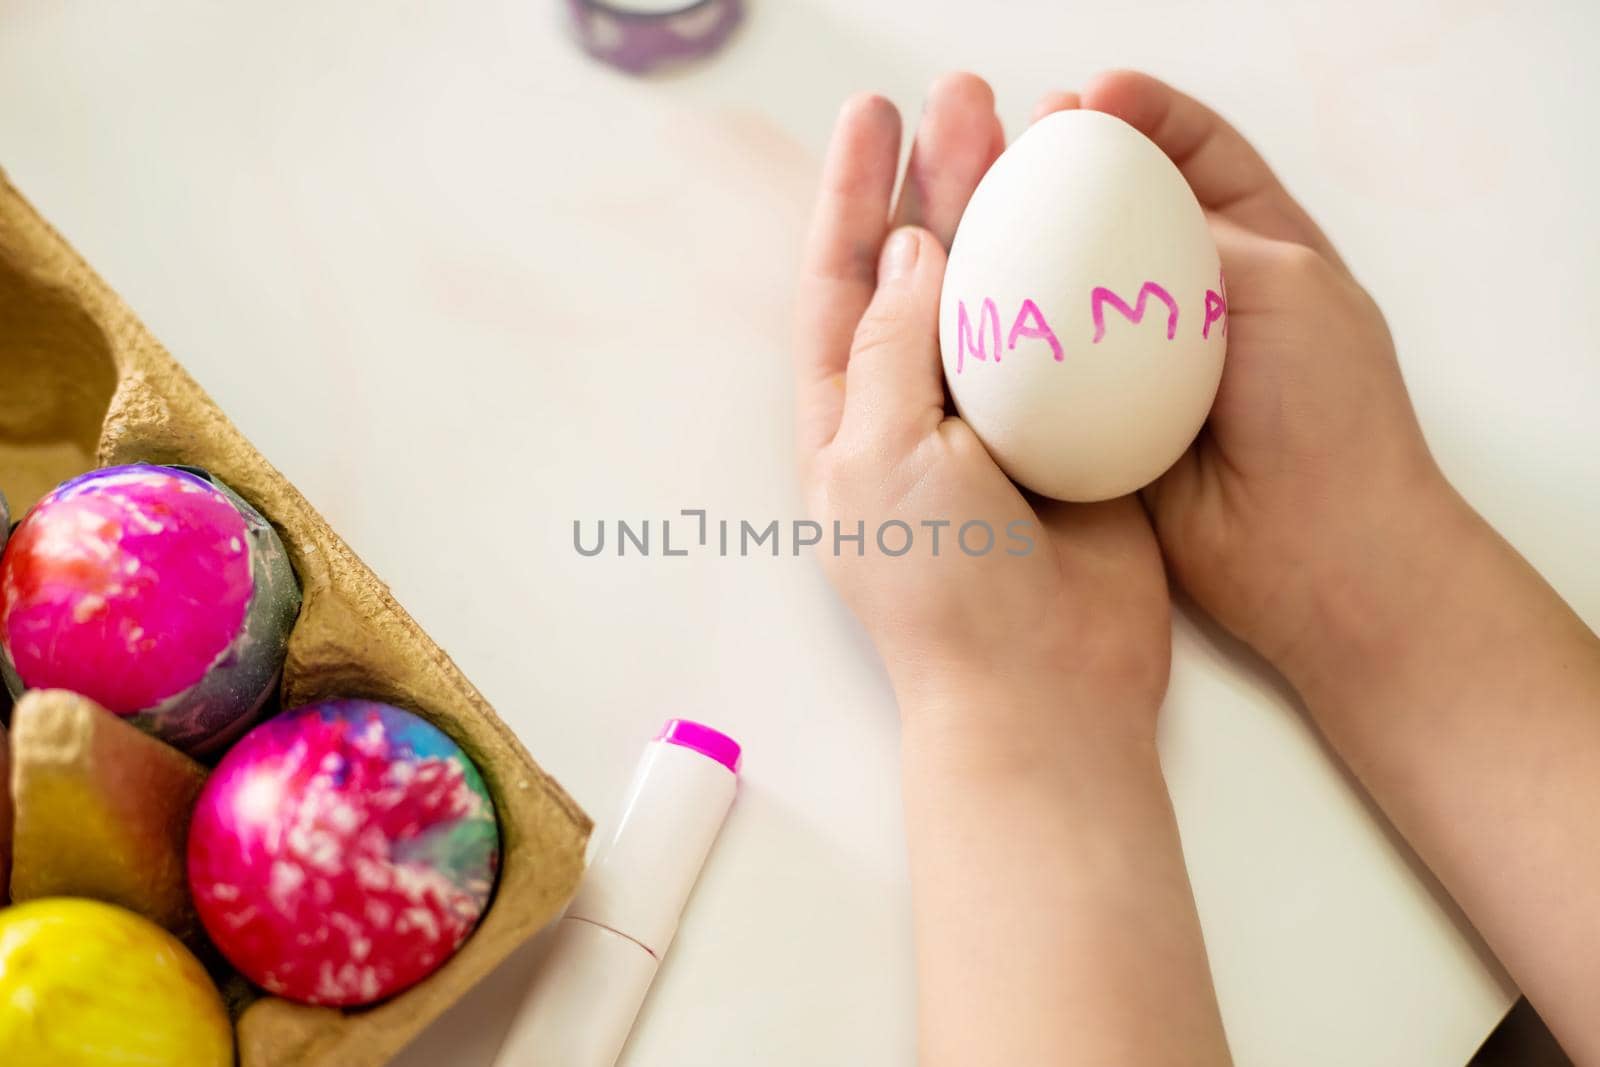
894, 74, 1005, 248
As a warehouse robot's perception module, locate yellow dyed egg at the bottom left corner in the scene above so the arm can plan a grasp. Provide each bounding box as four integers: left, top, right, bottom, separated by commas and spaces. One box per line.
0, 897, 234, 1067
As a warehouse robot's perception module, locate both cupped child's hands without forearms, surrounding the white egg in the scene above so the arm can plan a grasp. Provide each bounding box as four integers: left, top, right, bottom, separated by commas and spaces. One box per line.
798, 72, 1461, 709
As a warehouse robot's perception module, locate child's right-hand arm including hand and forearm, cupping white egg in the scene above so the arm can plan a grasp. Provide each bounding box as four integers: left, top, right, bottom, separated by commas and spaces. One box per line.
1083, 74, 1600, 1064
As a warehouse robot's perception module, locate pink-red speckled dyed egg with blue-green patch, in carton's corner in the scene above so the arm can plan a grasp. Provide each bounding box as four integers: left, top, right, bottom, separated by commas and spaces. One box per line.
189, 701, 499, 1006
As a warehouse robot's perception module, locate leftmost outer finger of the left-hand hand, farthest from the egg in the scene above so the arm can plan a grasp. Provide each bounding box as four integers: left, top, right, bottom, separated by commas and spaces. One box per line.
795, 94, 901, 461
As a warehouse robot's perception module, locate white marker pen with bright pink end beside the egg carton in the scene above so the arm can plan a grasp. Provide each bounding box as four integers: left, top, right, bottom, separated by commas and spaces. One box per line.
494, 718, 739, 1067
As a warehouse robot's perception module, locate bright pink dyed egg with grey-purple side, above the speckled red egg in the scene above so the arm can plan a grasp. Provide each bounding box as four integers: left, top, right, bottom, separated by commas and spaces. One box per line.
0, 464, 301, 755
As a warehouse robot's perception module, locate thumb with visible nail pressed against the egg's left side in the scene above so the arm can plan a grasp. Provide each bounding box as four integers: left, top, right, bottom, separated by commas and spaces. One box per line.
840, 226, 944, 446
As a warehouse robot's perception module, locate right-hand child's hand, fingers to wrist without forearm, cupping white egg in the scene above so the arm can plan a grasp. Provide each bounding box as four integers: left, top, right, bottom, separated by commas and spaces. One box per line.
1083, 72, 1450, 665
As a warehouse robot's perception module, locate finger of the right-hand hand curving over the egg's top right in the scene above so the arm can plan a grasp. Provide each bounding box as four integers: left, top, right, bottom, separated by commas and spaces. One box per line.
1083, 70, 1344, 267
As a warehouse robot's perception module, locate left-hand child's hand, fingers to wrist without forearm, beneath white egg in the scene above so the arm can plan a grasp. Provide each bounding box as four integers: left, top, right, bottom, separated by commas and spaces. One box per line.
798, 75, 1170, 736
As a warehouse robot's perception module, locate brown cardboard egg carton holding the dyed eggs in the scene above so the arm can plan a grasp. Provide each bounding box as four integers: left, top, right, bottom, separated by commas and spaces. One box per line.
0, 173, 590, 1067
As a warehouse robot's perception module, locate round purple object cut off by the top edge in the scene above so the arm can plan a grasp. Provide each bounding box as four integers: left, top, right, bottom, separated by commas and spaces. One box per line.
566, 0, 744, 74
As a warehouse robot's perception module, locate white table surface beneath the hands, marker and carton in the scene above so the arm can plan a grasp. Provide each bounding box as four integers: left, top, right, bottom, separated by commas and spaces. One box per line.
0, 0, 1600, 1067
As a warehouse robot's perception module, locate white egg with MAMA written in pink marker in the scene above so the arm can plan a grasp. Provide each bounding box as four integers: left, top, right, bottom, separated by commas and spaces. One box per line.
939, 110, 1227, 501
